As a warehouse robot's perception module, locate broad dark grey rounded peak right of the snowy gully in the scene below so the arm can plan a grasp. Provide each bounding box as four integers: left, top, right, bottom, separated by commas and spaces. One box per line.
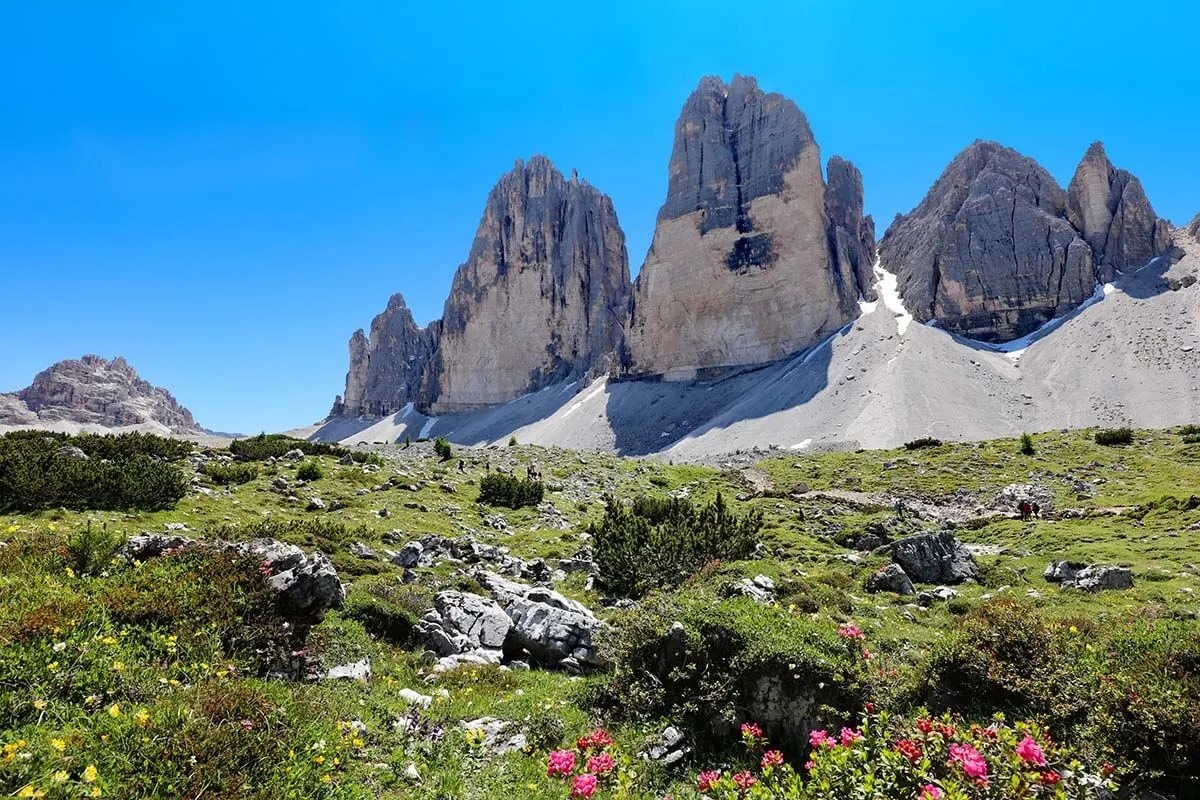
880, 142, 1096, 342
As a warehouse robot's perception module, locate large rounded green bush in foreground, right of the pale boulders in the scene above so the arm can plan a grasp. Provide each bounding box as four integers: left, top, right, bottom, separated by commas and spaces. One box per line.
595, 583, 862, 743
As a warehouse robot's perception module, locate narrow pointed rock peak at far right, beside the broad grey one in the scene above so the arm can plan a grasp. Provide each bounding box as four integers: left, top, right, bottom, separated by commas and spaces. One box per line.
1067, 142, 1171, 283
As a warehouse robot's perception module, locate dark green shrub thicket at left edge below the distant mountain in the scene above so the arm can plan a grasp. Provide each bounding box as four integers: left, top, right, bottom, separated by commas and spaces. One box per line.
0, 432, 191, 511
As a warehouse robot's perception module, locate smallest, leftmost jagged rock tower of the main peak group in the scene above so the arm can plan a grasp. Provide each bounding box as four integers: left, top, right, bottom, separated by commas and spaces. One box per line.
335, 294, 434, 416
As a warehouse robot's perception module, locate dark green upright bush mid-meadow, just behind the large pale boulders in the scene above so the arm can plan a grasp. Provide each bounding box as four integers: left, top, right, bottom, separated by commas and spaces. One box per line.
588, 494, 762, 597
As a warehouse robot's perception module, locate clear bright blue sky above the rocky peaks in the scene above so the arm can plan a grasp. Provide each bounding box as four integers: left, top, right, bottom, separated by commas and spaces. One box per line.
0, 0, 1200, 433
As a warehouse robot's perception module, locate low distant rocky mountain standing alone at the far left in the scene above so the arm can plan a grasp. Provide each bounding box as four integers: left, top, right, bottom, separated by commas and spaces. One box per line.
0, 355, 202, 433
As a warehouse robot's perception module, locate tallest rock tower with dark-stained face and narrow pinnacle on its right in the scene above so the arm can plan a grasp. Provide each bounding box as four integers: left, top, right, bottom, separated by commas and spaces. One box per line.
626, 76, 874, 379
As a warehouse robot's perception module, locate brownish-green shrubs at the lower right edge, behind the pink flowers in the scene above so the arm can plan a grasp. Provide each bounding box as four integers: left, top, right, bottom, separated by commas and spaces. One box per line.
913, 601, 1200, 788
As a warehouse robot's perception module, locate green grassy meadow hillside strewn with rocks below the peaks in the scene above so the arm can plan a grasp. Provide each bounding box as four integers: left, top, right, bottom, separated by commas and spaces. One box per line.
0, 431, 1200, 799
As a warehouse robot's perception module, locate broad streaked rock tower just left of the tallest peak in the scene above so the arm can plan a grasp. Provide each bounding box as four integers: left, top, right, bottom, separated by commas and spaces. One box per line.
433, 156, 630, 413
